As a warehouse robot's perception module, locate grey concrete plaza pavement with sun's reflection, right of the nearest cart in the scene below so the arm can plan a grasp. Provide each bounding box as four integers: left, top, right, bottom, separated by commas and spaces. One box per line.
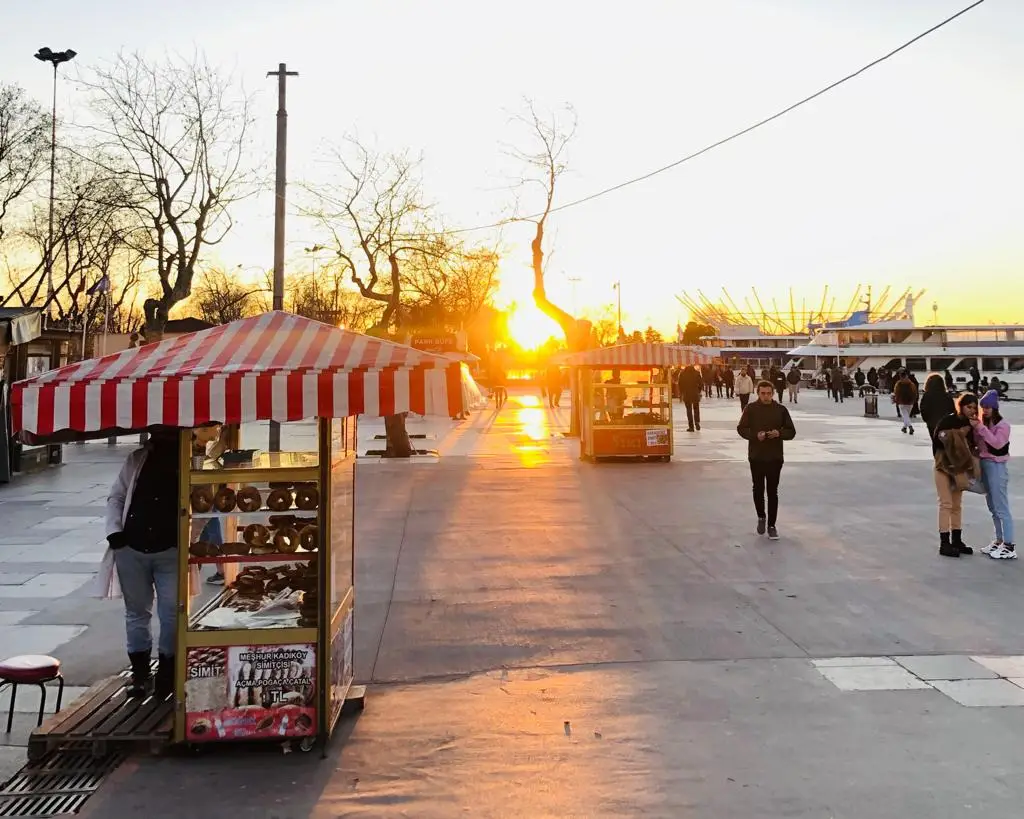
8, 395, 1024, 819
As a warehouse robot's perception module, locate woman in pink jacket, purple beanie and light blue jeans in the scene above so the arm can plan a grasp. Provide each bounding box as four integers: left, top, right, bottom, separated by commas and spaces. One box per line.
971, 390, 1017, 560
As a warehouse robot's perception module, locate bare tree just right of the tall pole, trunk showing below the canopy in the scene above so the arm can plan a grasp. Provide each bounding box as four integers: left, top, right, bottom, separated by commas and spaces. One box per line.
306, 138, 447, 458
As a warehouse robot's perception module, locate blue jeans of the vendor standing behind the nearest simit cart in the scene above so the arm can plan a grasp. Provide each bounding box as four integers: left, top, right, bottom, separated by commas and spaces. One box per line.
114, 546, 178, 657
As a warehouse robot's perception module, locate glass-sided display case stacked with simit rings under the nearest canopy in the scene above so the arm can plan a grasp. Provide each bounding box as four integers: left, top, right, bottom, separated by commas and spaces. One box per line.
175, 418, 355, 749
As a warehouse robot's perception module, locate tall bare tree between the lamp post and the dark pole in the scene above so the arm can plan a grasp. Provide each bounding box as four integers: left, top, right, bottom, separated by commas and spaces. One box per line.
81, 53, 255, 341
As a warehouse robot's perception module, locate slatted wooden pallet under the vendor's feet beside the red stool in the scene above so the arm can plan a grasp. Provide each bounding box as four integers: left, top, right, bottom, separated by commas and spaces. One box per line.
29, 672, 174, 761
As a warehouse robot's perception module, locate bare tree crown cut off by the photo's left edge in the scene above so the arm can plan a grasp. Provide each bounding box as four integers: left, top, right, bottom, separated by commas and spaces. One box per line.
0, 83, 49, 240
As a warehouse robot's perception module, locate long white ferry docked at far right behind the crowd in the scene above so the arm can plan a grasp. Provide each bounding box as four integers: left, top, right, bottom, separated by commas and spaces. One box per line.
788, 317, 1024, 398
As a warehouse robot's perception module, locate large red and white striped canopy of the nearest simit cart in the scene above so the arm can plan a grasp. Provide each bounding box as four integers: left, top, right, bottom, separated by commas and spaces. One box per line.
11, 311, 470, 436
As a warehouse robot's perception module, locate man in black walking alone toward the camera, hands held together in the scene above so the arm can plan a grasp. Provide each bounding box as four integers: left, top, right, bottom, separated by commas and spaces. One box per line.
736, 381, 797, 541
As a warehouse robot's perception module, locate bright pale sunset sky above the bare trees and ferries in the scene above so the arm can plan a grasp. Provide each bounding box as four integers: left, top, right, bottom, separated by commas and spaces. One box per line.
0, 0, 1024, 337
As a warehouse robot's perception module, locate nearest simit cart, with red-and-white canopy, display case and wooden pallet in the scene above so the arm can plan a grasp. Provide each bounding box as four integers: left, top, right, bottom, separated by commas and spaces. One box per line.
12, 311, 473, 755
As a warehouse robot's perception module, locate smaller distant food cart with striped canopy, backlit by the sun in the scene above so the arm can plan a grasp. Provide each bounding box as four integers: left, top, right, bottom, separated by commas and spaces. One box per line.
561, 344, 699, 461
